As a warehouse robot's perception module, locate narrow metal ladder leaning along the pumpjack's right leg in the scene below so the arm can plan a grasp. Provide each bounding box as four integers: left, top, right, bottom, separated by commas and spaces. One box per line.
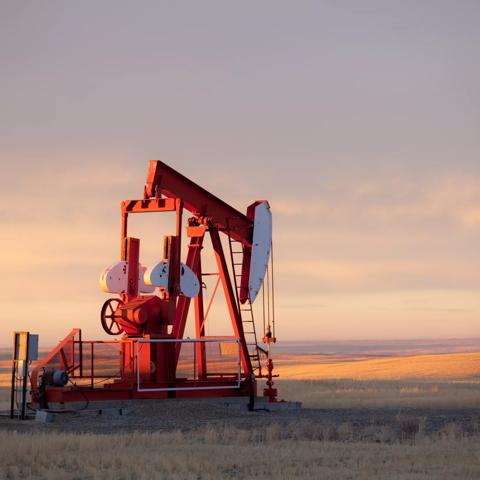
227, 230, 264, 376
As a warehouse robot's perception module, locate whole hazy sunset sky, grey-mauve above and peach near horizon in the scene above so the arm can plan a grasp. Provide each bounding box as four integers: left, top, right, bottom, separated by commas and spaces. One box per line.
0, 0, 480, 346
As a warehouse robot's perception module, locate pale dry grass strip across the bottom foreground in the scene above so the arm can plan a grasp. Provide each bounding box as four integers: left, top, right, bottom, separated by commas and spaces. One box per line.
0, 424, 480, 480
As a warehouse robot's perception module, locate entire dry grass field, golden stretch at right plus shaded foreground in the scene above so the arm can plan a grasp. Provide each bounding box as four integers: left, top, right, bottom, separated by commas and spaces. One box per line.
0, 353, 480, 480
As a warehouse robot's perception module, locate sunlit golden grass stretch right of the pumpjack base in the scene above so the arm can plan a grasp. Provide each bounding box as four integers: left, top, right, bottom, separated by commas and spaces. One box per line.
275, 352, 480, 408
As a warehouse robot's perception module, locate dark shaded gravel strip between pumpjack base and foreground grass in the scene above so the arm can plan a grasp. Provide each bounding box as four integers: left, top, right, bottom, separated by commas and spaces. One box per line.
0, 398, 480, 439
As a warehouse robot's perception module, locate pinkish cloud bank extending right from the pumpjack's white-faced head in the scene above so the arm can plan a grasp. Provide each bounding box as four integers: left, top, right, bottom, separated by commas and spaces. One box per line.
271, 174, 480, 228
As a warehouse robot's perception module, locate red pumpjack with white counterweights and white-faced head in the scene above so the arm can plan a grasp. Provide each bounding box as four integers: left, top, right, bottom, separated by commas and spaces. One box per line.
30, 160, 277, 405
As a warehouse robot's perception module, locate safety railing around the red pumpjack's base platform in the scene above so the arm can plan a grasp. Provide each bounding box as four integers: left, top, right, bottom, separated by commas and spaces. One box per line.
30, 329, 242, 400
